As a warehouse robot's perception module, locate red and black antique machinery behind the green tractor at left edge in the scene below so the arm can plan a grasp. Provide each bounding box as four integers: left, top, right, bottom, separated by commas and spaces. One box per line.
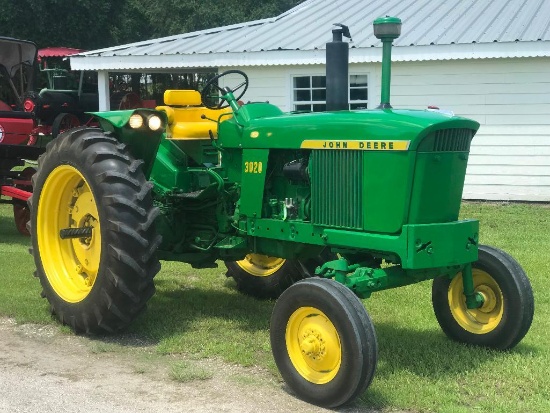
0, 37, 141, 234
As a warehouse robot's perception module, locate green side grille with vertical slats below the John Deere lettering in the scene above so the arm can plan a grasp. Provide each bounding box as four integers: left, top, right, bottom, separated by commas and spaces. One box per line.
309, 150, 364, 229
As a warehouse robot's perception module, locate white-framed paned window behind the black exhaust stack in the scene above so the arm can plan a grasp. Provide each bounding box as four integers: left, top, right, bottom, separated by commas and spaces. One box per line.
292, 74, 369, 112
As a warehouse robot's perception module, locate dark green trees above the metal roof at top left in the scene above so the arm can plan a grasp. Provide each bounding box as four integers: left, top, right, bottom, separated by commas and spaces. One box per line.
0, 0, 301, 50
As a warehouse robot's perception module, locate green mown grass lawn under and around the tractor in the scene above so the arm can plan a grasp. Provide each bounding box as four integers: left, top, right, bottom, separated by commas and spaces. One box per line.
0, 203, 550, 413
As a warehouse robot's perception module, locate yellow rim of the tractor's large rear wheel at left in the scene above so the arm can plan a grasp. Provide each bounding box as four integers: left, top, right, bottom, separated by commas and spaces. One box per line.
36, 165, 101, 303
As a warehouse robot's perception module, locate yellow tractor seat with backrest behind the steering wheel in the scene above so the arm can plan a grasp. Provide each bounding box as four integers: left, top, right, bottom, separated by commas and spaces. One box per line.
156, 90, 230, 139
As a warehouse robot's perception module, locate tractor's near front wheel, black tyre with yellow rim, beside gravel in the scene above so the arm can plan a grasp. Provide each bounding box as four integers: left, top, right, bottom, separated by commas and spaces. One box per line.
270, 278, 378, 408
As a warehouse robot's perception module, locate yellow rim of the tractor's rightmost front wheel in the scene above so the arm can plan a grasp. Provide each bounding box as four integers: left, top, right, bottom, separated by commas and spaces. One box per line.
448, 268, 504, 334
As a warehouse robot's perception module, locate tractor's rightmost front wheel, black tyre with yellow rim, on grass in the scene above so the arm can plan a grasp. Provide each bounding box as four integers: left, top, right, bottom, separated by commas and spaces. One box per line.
432, 245, 535, 350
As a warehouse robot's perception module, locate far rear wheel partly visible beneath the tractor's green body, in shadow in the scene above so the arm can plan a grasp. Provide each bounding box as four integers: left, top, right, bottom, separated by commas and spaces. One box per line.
225, 252, 332, 299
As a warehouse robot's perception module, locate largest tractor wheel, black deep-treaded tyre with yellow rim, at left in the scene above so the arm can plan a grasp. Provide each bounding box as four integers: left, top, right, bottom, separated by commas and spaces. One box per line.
29, 128, 160, 334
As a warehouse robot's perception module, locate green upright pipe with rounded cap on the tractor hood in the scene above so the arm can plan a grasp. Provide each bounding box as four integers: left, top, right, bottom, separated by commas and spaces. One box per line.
374, 16, 401, 109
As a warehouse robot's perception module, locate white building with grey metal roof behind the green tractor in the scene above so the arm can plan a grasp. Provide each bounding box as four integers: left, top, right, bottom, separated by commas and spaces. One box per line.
71, 0, 550, 201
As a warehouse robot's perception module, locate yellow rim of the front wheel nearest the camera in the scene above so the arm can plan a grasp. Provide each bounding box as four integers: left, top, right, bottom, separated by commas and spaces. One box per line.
285, 307, 342, 384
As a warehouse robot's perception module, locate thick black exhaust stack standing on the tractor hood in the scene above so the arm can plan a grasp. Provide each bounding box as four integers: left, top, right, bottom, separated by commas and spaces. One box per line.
326, 24, 351, 111
